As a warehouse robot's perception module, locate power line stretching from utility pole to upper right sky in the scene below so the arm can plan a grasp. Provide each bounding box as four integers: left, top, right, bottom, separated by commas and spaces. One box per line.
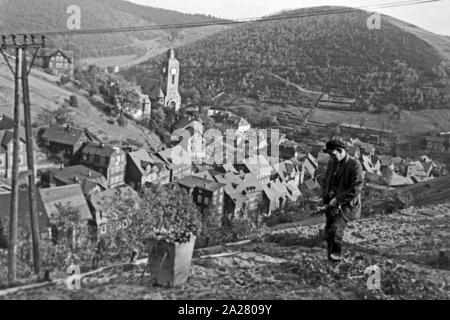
8, 0, 442, 36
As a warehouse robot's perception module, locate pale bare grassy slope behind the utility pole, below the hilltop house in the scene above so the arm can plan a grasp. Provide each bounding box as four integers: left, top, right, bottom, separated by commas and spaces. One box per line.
0, 64, 160, 151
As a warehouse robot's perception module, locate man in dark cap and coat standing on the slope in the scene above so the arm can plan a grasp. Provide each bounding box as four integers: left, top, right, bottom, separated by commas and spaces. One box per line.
322, 140, 364, 262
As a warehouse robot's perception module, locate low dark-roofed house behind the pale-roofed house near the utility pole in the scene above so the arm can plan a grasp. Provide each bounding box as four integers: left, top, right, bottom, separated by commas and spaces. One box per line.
41, 164, 108, 197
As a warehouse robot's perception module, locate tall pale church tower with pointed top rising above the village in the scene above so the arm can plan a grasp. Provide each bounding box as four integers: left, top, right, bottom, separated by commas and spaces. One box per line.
164, 49, 181, 112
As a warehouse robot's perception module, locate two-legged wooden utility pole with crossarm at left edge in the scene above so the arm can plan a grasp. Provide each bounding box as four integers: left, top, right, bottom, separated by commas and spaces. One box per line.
0, 35, 45, 284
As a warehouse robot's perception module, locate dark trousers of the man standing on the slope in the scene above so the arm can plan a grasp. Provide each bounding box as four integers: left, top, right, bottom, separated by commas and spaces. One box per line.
324, 208, 347, 257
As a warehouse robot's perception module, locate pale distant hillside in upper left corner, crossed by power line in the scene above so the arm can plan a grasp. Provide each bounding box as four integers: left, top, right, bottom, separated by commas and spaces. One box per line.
0, 0, 221, 58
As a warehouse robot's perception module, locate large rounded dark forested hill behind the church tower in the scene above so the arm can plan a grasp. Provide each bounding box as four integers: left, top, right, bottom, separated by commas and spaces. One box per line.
127, 7, 450, 112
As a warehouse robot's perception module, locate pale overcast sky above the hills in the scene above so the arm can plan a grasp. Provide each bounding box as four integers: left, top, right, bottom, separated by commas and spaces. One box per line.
128, 0, 450, 35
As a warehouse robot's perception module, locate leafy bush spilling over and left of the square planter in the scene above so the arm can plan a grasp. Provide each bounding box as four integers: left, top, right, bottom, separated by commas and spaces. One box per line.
101, 185, 202, 260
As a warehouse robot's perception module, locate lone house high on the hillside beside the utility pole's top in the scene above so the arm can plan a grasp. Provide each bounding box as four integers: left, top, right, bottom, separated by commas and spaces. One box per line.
37, 49, 74, 77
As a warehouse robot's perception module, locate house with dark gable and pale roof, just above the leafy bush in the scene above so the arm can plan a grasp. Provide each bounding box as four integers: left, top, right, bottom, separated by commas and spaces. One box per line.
125, 149, 170, 191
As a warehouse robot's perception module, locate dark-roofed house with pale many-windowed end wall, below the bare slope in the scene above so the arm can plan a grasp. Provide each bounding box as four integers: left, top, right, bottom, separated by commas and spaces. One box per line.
80, 142, 127, 188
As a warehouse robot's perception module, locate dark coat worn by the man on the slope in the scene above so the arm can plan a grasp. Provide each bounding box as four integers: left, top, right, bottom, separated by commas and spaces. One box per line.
323, 154, 364, 221
